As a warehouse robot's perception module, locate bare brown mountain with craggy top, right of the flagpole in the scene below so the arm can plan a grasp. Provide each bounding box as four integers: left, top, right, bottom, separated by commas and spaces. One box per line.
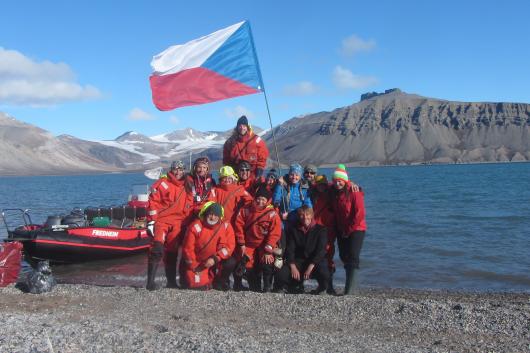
264, 89, 530, 165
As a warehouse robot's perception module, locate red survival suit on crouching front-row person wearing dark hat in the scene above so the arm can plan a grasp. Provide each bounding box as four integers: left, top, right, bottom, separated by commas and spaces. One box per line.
234, 205, 282, 269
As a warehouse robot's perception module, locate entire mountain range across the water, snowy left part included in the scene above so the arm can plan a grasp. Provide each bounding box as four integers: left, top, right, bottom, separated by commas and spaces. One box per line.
0, 89, 530, 175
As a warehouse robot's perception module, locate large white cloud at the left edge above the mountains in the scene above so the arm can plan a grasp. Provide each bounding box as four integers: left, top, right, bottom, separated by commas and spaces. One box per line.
0, 47, 102, 106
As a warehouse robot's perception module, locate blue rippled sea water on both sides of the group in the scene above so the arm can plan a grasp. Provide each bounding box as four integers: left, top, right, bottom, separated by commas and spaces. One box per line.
0, 163, 530, 291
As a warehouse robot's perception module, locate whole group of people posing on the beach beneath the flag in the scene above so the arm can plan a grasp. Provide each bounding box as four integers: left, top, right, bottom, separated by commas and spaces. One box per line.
146, 116, 366, 294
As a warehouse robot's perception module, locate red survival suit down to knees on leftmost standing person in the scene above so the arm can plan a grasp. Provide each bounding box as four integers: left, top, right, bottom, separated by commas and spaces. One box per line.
147, 173, 193, 253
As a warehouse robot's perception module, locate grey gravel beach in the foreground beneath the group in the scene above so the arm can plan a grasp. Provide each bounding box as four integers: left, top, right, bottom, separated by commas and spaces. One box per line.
0, 284, 530, 353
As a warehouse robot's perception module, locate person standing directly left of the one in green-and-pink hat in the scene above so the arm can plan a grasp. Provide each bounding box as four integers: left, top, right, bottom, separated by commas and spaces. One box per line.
311, 175, 337, 294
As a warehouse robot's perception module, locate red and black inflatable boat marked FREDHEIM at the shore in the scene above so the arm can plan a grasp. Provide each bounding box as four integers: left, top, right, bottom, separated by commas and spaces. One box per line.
2, 205, 151, 263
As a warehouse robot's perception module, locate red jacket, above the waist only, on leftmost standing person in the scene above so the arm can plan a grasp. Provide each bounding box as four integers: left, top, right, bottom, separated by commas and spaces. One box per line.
147, 173, 192, 223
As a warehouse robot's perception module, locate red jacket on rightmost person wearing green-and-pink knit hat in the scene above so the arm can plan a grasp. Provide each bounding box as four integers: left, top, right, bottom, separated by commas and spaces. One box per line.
331, 183, 366, 235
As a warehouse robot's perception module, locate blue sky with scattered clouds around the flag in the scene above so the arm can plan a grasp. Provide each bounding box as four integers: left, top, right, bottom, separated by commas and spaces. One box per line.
0, 0, 530, 140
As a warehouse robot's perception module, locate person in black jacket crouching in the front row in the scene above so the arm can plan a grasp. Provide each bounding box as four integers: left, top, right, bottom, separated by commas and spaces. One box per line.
279, 205, 330, 294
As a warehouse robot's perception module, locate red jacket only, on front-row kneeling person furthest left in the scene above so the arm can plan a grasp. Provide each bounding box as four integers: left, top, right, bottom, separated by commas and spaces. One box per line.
182, 219, 234, 270
